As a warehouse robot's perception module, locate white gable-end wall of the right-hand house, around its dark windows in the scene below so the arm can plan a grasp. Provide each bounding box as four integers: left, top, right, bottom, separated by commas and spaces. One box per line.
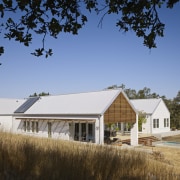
152, 101, 170, 133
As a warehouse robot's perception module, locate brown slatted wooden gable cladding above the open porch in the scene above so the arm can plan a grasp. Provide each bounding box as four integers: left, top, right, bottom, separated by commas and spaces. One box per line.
104, 93, 136, 124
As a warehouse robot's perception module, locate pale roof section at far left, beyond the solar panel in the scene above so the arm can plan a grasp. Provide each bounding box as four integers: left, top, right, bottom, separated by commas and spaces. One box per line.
0, 98, 26, 115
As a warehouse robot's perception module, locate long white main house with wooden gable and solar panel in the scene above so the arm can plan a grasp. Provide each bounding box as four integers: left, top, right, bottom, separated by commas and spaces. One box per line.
13, 89, 138, 145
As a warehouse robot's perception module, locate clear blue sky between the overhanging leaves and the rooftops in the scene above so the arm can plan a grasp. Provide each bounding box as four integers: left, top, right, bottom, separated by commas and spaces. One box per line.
0, 4, 180, 98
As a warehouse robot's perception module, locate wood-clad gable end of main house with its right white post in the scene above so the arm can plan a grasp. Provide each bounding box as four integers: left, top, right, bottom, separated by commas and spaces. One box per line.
104, 92, 138, 146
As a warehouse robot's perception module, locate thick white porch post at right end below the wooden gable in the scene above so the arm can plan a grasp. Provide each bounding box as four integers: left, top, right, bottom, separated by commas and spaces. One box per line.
131, 114, 138, 146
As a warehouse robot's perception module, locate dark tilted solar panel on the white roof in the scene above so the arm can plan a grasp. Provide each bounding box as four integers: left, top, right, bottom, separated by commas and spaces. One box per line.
14, 97, 39, 113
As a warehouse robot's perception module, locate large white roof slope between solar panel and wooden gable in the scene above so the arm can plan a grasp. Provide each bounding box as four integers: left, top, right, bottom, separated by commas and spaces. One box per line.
24, 89, 122, 115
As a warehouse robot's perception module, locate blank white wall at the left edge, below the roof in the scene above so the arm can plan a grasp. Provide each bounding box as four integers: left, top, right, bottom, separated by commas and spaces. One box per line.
0, 116, 12, 132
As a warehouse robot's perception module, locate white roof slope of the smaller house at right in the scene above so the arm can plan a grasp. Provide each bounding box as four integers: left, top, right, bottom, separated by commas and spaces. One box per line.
130, 98, 161, 114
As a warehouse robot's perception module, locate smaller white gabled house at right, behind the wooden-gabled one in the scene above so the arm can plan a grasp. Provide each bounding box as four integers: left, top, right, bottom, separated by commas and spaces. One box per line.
131, 98, 170, 134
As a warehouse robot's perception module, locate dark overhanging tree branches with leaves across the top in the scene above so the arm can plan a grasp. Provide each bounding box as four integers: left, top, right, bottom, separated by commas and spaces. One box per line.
0, 0, 179, 57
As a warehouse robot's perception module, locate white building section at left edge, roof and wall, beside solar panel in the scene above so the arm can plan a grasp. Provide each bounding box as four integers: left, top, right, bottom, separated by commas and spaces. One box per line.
0, 98, 25, 132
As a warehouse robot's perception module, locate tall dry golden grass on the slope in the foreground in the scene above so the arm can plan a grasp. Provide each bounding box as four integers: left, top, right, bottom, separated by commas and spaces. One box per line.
0, 132, 180, 180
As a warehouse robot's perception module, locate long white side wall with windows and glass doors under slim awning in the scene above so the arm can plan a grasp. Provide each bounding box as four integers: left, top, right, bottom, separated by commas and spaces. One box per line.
13, 117, 99, 143
